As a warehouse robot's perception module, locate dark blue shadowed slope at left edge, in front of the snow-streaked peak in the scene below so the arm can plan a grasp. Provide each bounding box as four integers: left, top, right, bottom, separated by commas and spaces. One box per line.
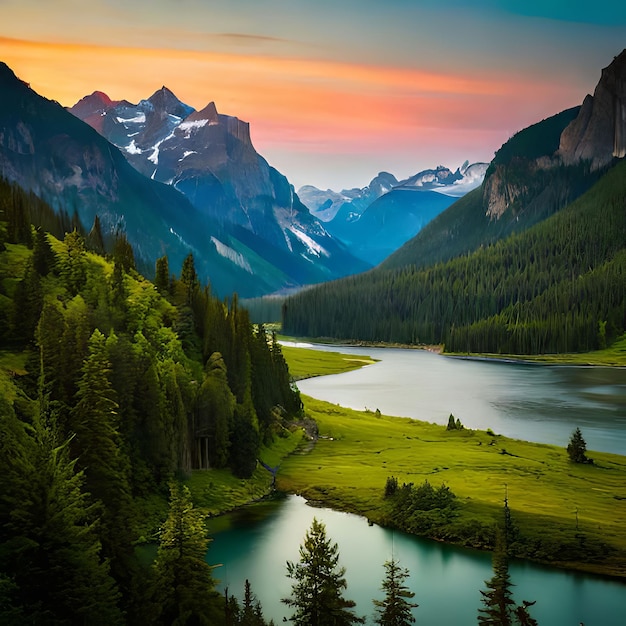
0, 64, 219, 278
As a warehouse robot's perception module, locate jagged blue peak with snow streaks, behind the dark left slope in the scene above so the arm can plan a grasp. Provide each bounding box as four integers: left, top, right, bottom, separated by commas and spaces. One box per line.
70, 87, 370, 296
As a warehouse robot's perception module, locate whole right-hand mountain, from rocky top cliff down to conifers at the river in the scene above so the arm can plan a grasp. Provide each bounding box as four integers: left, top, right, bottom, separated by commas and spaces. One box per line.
283, 51, 626, 354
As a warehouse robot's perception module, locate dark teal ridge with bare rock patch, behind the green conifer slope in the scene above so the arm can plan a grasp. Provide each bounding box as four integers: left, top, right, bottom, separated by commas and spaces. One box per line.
381, 107, 604, 269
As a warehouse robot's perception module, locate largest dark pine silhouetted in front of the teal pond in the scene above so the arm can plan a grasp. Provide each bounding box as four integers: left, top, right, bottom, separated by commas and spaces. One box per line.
282, 518, 365, 626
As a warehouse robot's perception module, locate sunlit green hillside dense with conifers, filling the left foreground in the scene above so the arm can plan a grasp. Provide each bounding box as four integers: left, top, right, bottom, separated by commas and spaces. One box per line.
0, 177, 301, 625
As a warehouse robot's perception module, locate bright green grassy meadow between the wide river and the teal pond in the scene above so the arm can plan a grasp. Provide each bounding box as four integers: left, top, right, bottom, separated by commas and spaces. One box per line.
277, 348, 626, 577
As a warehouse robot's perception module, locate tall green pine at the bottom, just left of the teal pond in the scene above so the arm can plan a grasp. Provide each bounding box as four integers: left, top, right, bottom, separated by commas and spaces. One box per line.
153, 482, 223, 626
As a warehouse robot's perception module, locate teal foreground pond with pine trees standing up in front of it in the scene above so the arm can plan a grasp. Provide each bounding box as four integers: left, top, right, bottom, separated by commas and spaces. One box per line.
207, 496, 626, 626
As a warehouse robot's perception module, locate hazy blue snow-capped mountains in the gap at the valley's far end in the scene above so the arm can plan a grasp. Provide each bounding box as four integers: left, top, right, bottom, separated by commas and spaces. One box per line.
298, 161, 488, 264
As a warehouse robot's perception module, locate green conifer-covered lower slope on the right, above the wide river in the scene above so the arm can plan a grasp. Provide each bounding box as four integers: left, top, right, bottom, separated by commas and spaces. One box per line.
283, 162, 626, 354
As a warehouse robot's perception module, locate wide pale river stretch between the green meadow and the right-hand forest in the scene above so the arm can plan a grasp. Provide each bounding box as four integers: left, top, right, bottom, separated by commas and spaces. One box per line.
291, 344, 626, 454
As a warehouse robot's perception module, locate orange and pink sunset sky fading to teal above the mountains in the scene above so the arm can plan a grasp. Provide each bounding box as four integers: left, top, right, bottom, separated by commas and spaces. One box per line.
0, 0, 626, 190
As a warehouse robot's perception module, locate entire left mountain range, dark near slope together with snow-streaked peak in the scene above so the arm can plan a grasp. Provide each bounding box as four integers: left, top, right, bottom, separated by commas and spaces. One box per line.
0, 64, 370, 296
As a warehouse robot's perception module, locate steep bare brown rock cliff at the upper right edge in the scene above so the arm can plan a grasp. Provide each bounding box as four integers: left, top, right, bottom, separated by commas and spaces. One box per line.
559, 50, 626, 169
